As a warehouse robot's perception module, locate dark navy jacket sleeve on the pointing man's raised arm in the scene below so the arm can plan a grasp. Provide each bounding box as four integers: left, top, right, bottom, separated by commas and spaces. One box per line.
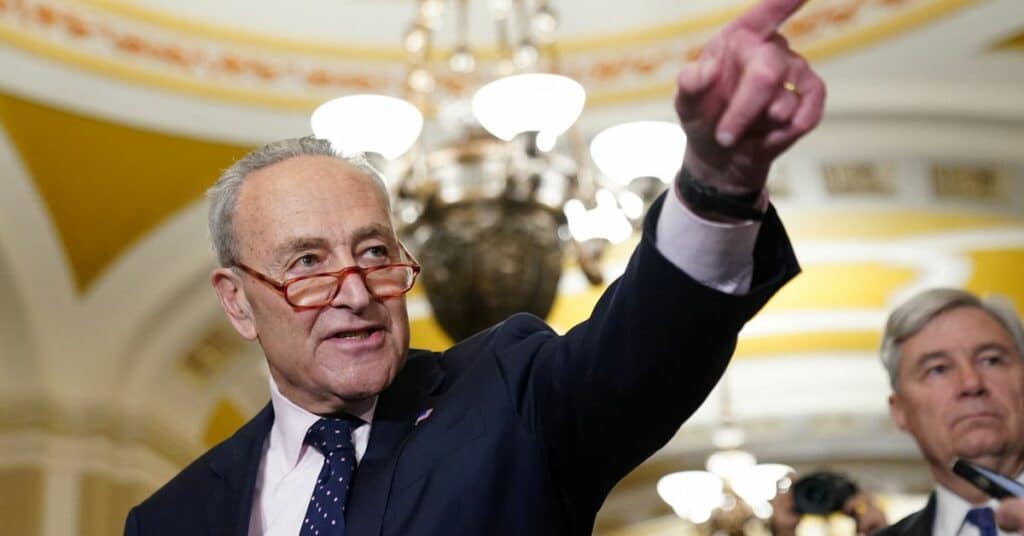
489, 191, 799, 509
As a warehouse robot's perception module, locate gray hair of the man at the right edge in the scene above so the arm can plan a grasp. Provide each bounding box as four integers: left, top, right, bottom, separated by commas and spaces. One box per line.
880, 288, 1024, 390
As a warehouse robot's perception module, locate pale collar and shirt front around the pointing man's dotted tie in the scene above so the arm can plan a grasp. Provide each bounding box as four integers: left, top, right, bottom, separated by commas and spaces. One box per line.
249, 378, 377, 536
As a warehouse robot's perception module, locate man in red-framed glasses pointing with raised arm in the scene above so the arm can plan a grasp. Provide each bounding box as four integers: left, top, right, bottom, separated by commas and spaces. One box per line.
125, 0, 824, 536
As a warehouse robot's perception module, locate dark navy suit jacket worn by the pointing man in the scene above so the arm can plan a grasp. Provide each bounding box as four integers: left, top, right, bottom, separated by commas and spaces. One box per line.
125, 201, 799, 536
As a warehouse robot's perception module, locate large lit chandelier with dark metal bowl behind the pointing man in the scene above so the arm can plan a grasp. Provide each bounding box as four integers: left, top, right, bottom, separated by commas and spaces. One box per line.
311, 0, 685, 340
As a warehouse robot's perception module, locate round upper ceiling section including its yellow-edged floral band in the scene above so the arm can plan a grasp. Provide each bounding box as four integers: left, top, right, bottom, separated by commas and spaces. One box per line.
0, 0, 995, 111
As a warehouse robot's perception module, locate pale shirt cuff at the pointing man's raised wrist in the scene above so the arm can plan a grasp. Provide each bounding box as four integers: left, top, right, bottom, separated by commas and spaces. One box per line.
654, 189, 767, 294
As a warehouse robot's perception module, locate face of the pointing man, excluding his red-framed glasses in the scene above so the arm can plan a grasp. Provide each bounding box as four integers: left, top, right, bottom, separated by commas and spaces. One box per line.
213, 156, 409, 413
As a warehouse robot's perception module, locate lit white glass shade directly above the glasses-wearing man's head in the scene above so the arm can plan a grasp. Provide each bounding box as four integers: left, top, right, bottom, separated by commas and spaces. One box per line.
309, 94, 423, 160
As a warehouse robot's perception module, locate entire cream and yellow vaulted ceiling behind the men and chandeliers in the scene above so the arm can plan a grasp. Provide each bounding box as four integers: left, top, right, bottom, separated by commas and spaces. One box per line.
0, 0, 1024, 534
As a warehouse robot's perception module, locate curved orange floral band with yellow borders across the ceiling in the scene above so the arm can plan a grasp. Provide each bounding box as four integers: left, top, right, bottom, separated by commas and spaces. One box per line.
0, 0, 977, 110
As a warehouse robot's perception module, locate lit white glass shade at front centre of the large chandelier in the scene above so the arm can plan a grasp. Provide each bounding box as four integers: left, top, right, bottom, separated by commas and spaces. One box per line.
473, 73, 587, 141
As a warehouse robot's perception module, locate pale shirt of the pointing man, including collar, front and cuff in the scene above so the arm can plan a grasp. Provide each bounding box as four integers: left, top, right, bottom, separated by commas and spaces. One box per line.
249, 192, 761, 536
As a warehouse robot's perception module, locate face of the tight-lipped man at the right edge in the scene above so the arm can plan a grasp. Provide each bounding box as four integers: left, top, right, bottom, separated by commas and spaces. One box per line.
889, 306, 1024, 471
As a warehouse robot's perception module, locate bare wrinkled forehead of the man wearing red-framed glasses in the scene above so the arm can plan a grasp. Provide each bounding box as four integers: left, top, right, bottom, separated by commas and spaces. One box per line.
233, 156, 392, 255
